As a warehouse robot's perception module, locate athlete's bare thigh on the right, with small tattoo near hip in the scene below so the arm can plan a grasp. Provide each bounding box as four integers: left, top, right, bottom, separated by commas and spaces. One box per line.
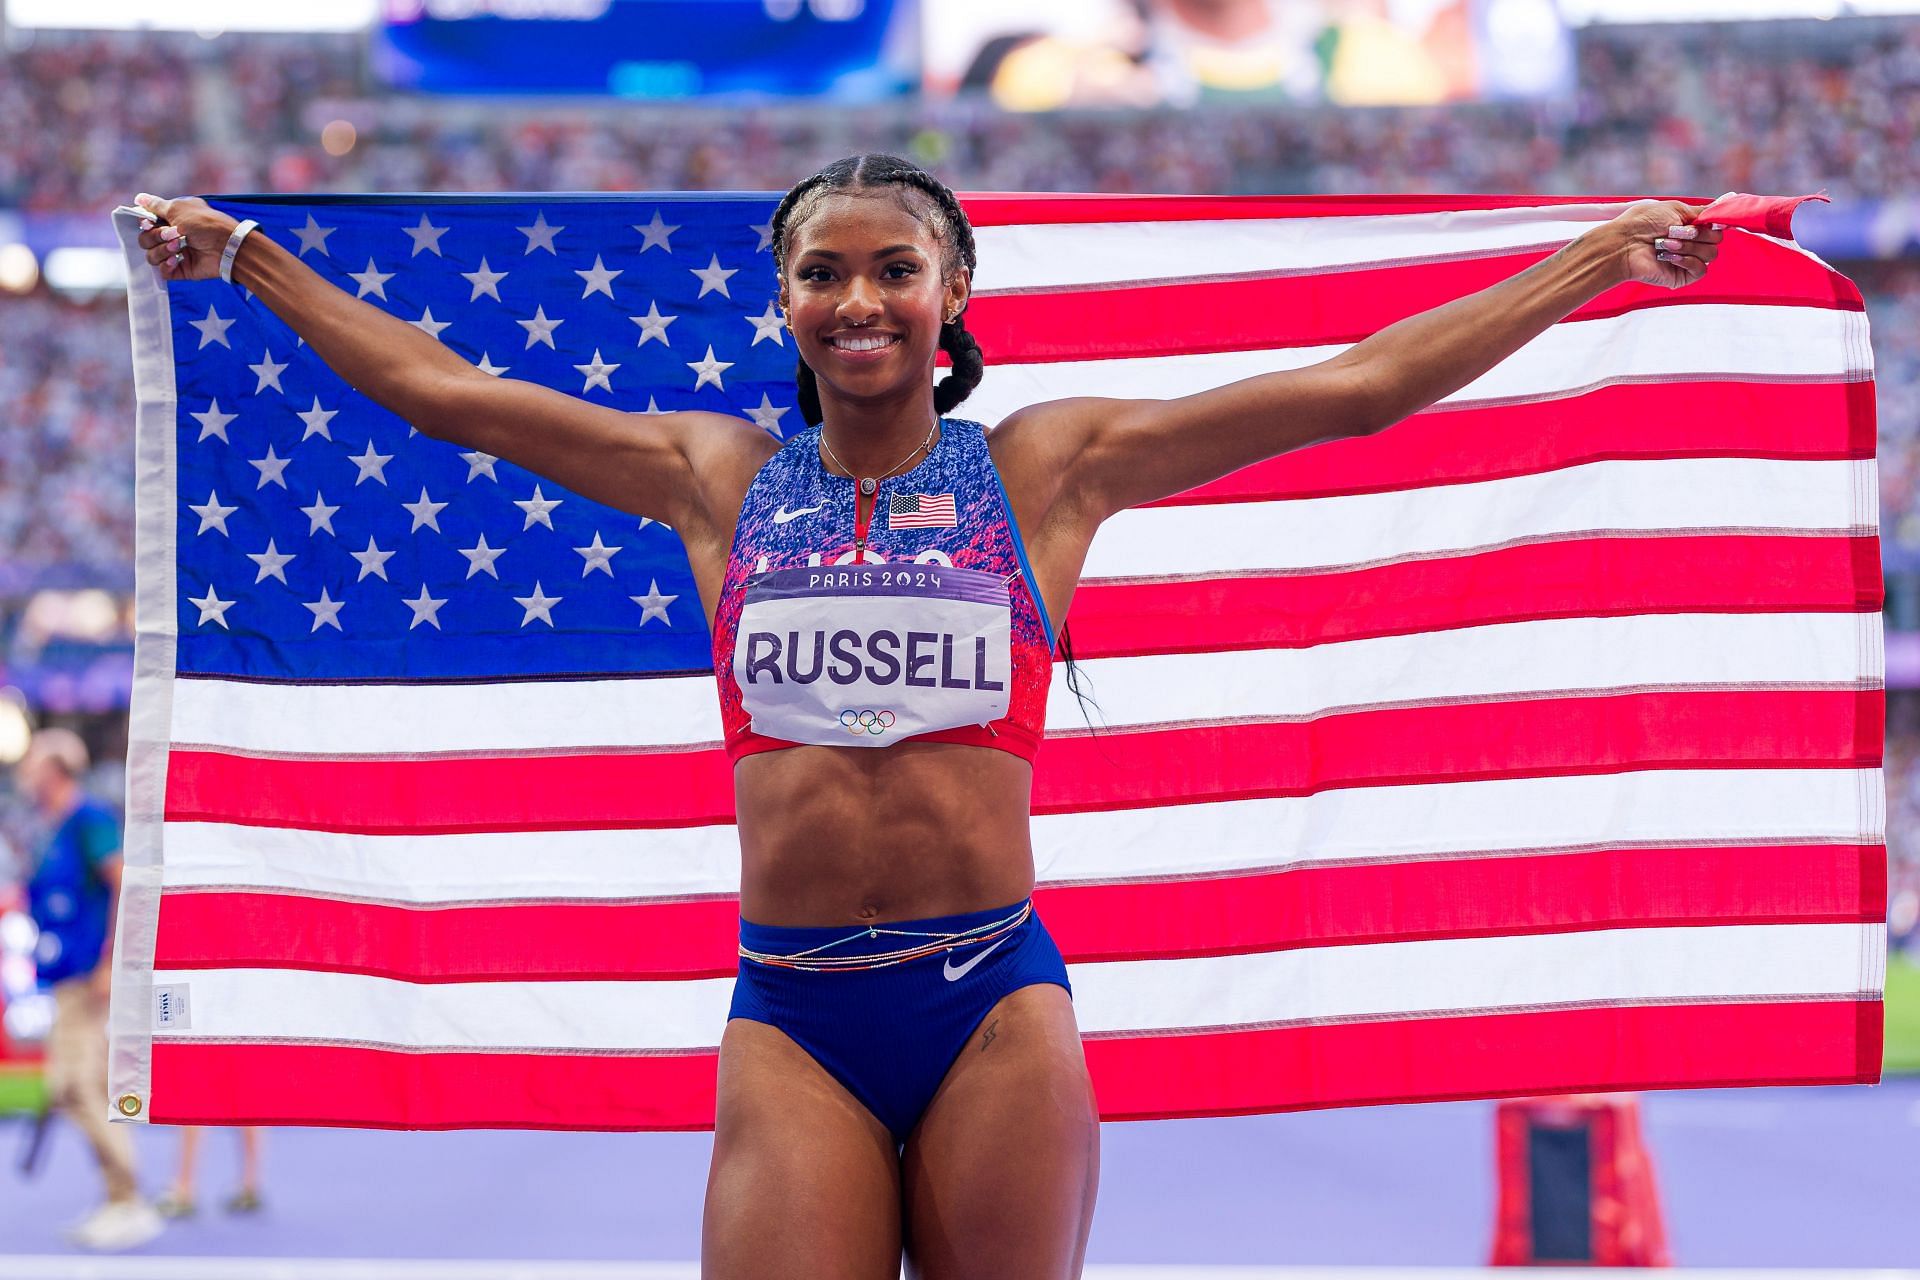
900, 983, 1100, 1280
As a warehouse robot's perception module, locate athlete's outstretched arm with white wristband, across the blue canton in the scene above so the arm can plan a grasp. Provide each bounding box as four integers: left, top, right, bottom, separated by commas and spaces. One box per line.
127, 196, 774, 530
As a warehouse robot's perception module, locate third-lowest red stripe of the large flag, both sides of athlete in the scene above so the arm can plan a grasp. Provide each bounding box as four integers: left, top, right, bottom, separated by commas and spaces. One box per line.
165, 689, 1885, 835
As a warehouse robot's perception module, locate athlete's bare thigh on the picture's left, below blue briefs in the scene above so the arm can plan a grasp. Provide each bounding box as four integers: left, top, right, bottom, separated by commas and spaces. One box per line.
701, 1019, 900, 1280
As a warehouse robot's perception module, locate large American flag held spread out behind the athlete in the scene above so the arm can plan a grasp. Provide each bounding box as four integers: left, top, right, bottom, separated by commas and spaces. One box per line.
97, 196, 1885, 1128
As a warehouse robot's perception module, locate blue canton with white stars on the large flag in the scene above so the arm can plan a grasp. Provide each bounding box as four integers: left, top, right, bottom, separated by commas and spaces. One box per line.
169, 194, 787, 681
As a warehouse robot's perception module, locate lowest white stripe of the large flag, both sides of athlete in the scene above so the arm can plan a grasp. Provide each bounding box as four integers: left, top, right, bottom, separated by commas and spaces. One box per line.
154, 923, 1885, 1052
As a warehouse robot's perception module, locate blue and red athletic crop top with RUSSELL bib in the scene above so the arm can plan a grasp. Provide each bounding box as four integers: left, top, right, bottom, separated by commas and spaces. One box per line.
714, 418, 1054, 760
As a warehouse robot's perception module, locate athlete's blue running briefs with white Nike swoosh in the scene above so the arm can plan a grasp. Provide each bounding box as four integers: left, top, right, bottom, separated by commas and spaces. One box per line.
728, 902, 1073, 1144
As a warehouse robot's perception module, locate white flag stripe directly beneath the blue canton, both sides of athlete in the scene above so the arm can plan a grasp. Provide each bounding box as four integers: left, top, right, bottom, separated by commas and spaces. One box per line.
177, 612, 1880, 756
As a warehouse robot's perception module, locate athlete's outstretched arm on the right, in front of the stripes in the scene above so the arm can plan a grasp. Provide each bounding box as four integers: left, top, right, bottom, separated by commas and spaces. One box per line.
1000, 200, 1720, 518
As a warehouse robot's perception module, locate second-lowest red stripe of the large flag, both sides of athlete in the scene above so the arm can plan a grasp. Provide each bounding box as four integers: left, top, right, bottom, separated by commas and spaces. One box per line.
154, 844, 1887, 983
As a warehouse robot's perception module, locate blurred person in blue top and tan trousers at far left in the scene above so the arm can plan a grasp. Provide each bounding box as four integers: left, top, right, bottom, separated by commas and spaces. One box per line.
17, 727, 165, 1249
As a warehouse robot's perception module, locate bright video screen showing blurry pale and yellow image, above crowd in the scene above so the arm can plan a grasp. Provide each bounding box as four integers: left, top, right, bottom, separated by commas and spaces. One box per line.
922, 0, 1572, 111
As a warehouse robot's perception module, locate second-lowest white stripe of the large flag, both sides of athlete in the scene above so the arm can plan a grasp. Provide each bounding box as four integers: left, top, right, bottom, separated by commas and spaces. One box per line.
165, 770, 1885, 904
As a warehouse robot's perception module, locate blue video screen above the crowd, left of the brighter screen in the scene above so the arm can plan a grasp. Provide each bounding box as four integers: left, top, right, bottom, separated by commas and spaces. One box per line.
372, 0, 920, 102
